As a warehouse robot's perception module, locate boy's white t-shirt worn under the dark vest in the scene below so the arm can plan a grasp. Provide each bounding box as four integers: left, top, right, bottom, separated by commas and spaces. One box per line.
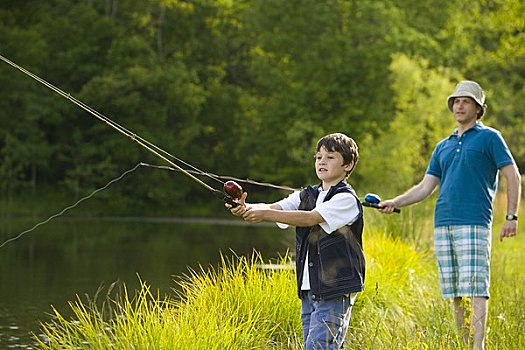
275, 187, 359, 290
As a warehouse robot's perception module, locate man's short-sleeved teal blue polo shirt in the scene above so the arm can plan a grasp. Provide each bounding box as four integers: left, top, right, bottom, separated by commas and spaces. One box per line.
426, 122, 514, 227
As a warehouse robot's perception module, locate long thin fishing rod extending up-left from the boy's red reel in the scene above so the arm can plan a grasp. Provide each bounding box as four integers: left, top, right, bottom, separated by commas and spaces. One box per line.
0, 54, 244, 206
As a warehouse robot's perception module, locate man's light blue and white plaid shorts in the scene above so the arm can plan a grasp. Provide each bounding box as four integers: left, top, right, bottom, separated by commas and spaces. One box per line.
434, 225, 492, 298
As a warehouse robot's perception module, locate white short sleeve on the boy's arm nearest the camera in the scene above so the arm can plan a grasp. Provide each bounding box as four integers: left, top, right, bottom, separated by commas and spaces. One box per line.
314, 193, 359, 233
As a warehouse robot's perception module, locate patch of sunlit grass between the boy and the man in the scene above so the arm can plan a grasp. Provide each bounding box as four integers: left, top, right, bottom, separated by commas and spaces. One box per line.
347, 232, 460, 349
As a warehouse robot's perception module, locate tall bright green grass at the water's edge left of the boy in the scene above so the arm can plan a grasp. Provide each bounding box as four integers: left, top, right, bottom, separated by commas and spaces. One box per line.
39, 256, 301, 349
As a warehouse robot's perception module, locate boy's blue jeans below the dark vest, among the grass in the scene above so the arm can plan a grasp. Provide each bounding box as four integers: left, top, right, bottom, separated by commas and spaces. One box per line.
301, 291, 356, 350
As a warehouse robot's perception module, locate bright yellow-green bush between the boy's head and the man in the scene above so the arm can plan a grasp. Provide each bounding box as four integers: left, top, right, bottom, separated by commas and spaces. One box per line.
356, 54, 454, 196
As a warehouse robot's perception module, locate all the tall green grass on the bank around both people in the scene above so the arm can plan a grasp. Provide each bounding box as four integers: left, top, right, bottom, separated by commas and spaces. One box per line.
34, 198, 525, 350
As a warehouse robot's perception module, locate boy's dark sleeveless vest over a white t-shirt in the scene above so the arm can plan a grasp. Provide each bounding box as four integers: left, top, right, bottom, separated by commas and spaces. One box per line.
296, 181, 365, 299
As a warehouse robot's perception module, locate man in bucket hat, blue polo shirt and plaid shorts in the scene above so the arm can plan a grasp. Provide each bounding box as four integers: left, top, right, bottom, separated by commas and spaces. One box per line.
380, 81, 521, 350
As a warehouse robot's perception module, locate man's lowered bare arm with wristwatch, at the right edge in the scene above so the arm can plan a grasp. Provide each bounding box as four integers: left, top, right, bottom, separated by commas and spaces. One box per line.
499, 164, 521, 241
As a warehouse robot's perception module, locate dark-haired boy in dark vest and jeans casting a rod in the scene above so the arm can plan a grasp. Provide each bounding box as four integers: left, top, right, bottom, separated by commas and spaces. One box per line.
226, 133, 365, 349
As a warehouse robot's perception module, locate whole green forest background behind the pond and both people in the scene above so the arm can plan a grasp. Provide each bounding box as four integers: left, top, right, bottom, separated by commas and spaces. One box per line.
0, 0, 525, 216
